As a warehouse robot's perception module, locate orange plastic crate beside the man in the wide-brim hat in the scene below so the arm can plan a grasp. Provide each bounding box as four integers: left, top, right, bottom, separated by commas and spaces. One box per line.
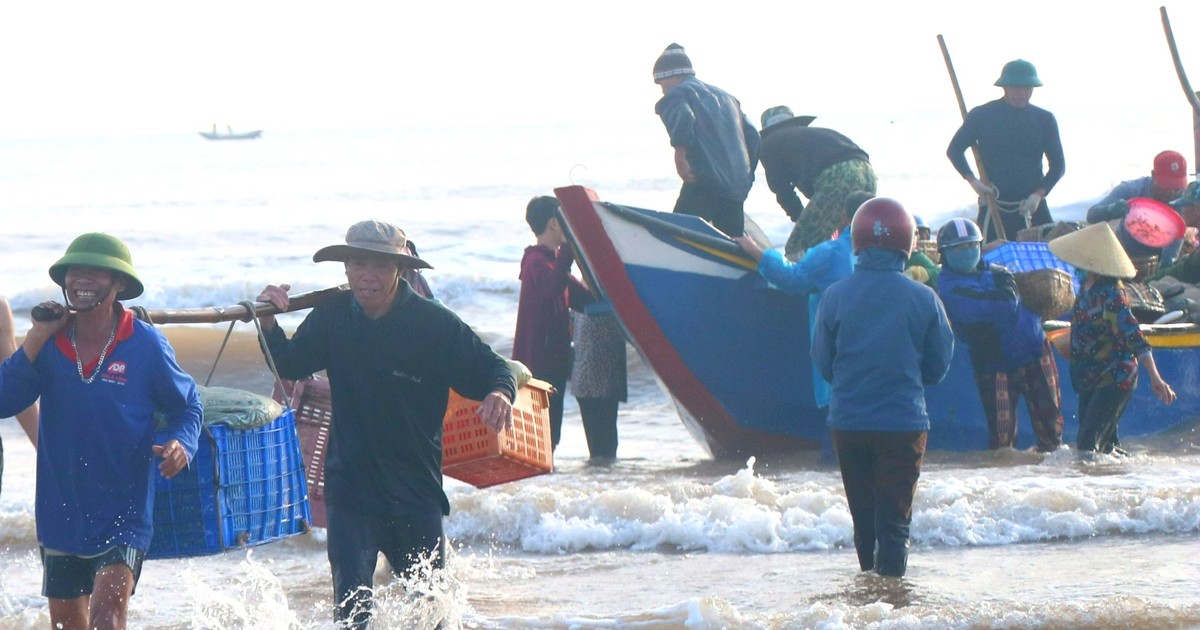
442, 379, 554, 488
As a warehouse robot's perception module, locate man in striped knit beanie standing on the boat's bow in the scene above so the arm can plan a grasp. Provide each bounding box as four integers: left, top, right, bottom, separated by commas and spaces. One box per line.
654, 43, 758, 236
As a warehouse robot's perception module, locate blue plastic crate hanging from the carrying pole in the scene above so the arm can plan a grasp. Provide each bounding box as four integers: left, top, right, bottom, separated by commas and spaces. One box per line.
148, 409, 312, 558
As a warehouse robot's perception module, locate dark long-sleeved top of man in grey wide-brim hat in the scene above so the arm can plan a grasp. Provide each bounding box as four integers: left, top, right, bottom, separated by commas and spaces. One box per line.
266, 282, 516, 515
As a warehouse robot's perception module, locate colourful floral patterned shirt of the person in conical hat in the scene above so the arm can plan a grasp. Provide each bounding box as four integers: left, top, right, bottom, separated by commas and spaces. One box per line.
1070, 278, 1150, 391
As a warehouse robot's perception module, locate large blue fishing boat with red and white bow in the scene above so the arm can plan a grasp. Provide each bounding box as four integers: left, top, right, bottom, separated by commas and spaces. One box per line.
554, 186, 1200, 457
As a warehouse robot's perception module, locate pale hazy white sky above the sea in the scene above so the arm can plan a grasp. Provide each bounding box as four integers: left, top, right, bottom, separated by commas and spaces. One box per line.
0, 0, 1200, 134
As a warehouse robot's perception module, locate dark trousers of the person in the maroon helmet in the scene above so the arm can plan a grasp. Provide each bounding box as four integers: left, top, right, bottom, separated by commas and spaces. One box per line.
833, 430, 929, 577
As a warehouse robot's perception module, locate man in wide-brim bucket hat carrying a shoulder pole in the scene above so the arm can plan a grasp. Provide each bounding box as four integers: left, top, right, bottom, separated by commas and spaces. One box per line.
258, 221, 516, 628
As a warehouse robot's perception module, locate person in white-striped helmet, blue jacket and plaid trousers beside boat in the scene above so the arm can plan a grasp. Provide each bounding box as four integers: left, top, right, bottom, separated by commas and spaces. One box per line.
937, 218, 1062, 452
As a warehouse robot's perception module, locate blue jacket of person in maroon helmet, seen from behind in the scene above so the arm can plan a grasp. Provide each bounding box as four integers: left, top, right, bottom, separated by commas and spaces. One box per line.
812, 247, 954, 431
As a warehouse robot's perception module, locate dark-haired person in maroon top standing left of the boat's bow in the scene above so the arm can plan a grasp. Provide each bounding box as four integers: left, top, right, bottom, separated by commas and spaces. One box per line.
512, 196, 592, 448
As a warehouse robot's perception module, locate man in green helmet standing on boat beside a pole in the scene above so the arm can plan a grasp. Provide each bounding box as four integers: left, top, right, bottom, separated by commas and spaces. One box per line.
946, 59, 1067, 241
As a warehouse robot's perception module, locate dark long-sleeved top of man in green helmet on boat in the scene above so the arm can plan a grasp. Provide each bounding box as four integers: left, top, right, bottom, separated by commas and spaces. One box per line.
946, 98, 1067, 202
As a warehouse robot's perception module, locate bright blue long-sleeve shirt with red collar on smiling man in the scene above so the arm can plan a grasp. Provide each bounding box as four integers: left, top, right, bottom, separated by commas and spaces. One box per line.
0, 310, 203, 556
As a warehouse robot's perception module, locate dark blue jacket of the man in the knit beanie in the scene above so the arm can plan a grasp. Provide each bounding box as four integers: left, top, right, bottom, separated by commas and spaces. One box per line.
654, 77, 760, 202
